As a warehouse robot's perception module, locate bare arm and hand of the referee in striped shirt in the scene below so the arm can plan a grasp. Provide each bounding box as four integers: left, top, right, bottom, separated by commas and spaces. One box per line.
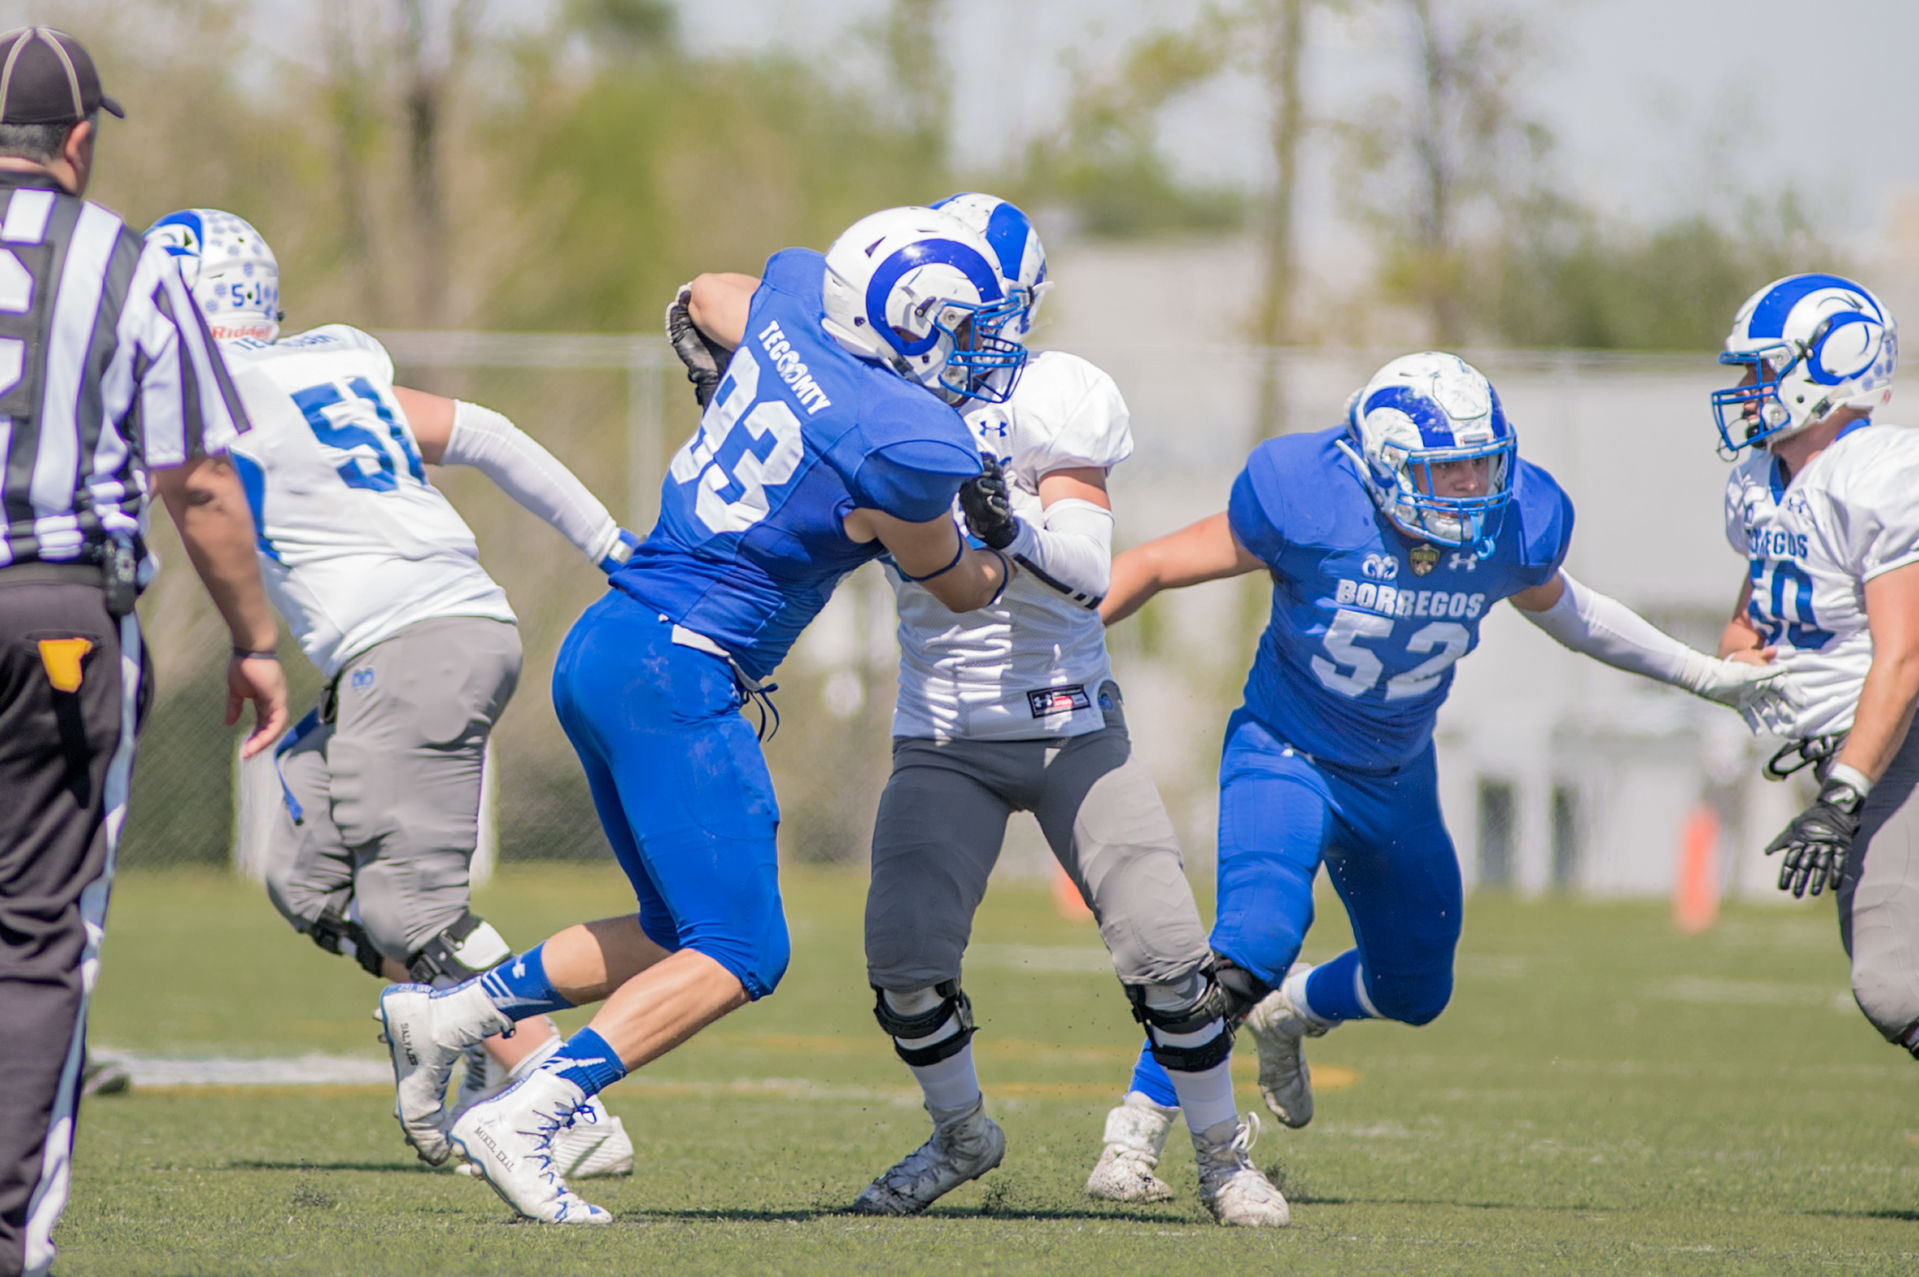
154, 457, 286, 759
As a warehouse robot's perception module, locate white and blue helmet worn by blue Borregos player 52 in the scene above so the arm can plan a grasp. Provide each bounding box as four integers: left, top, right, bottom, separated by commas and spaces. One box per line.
1339, 351, 1518, 559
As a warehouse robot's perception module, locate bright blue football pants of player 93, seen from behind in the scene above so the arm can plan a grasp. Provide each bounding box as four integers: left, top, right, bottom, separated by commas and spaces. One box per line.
553, 590, 791, 999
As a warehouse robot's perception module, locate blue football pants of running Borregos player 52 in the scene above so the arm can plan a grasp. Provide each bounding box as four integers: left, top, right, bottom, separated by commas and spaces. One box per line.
1132, 709, 1462, 1104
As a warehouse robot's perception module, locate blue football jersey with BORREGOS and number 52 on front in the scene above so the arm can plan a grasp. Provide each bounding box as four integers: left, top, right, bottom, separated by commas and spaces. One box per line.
1226, 428, 1572, 768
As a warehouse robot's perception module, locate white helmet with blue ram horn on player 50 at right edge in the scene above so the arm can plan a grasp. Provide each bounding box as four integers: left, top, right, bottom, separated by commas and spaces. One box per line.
1712, 275, 1900, 453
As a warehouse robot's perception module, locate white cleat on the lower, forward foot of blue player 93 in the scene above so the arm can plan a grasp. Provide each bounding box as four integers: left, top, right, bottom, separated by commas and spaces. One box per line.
447, 1070, 612, 1223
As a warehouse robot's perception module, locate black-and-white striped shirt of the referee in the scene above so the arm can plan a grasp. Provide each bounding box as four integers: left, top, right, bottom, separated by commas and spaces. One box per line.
0, 169, 248, 568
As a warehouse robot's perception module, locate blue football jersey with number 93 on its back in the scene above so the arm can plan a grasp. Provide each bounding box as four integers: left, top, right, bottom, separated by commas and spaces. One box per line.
612, 248, 979, 678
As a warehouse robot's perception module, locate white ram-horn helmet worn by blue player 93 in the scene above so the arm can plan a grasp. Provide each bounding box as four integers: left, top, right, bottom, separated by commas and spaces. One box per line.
821, 207, 1027, 403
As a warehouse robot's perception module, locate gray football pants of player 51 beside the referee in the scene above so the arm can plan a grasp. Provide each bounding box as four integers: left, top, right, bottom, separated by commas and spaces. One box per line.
267, 616, 520, 964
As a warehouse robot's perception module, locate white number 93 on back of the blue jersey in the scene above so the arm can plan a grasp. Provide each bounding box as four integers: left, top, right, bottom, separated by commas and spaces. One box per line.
668, 346, 806, 534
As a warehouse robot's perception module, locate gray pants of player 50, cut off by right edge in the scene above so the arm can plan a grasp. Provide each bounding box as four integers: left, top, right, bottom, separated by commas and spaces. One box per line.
1838, 730, 1919, 1054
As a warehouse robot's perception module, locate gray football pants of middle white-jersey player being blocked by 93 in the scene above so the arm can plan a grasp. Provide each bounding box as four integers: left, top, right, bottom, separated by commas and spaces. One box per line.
865, 684, 1211, 991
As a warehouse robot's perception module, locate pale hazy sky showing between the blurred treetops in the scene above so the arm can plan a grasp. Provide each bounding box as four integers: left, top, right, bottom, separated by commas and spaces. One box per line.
679, 0, 1919, 245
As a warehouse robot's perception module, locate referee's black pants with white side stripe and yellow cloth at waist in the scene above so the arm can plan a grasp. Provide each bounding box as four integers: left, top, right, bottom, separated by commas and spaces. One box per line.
0, 565, 152, 1277
